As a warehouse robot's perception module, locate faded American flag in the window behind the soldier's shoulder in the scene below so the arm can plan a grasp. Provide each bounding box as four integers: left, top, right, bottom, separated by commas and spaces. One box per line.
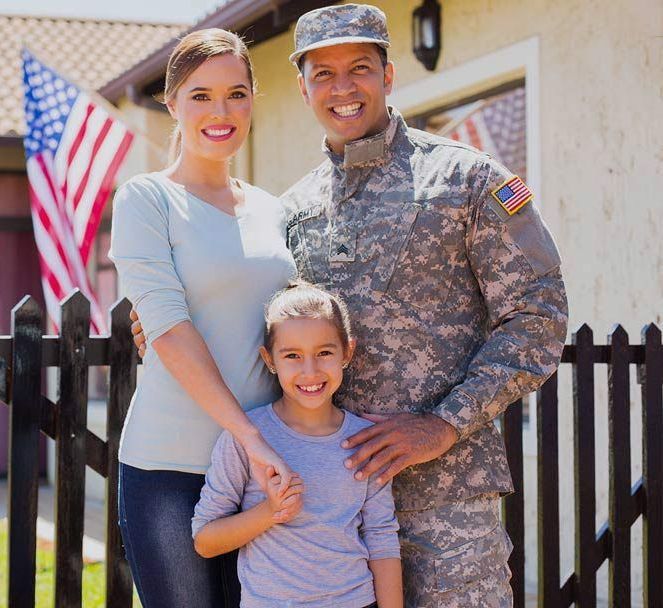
439, 87, 527, 179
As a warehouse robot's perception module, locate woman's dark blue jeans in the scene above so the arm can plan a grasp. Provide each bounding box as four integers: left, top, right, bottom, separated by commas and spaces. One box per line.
119, 463, 240, 608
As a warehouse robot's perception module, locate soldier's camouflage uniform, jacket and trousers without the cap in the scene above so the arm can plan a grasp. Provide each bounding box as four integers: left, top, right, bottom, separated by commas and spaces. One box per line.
283, 104, 567, 608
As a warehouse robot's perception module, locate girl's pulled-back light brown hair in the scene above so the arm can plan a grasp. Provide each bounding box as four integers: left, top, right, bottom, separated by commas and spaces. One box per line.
265, 281, 352, 352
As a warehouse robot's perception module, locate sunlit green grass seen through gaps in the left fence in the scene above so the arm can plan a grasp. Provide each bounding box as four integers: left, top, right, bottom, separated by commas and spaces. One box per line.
0, 519, 140, 608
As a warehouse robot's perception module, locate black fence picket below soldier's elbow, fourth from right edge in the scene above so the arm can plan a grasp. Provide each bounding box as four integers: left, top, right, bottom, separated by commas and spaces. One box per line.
536, 372, 561, 608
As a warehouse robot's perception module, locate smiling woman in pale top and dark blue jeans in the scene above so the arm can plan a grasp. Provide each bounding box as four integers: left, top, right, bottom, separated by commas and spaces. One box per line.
110, 29, 297, 608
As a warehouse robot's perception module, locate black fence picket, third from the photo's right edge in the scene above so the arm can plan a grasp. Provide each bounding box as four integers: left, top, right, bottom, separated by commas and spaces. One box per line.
573, 324, 597, 608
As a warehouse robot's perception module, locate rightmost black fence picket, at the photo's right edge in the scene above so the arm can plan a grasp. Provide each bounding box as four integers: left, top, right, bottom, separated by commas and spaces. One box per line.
640, 324, 663, 608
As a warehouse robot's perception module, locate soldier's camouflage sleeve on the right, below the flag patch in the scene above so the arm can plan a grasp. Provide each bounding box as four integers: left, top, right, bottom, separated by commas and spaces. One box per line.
434, 160, 568, 440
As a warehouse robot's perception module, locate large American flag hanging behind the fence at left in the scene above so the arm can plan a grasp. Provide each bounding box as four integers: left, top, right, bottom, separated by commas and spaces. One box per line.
22, 49, 133, 333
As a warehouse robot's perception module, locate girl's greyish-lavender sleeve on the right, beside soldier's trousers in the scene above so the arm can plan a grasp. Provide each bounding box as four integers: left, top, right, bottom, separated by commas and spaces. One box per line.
359, 476, 401, 559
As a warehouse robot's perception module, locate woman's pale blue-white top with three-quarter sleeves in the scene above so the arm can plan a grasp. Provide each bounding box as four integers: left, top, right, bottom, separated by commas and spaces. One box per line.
109, 173, 296, 474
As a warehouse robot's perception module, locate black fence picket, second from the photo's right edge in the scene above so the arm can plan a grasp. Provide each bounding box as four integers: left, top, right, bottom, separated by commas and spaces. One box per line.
608, 325, 631, 608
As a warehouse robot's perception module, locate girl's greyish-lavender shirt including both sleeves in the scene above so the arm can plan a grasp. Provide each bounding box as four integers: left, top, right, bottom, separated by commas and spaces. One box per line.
191, 405, 400, 608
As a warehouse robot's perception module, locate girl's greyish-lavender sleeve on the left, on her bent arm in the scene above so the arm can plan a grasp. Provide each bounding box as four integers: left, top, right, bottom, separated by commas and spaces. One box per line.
191, 431, 249, 538
